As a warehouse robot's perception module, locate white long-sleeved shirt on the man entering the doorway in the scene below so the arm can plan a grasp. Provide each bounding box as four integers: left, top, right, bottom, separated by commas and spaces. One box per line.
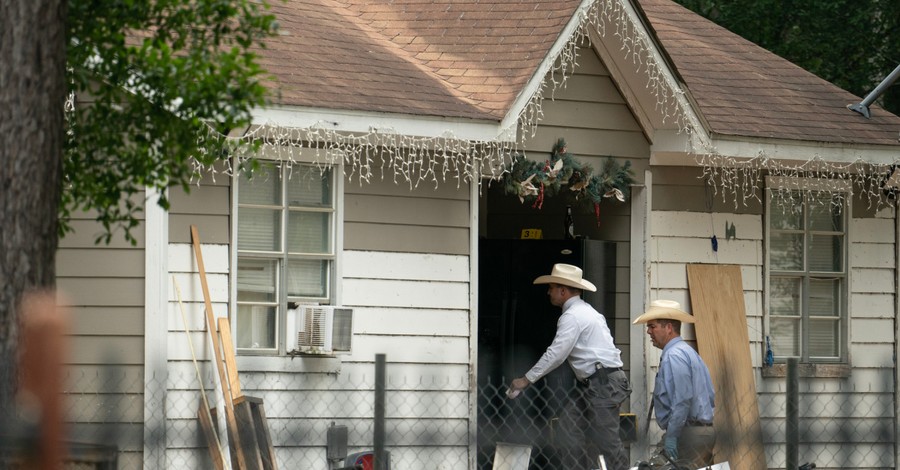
525, 296, 622, 383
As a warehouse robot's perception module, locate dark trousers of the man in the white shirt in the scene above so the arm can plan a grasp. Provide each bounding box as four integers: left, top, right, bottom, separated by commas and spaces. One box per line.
560, 369, 631, 470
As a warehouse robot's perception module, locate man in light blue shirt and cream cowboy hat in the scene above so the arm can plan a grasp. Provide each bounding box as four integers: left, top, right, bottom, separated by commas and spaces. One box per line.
634, 300, 716, 468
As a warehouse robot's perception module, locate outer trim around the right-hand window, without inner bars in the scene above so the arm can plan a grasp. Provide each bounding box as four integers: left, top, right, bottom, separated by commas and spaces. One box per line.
763, 176, 853, 366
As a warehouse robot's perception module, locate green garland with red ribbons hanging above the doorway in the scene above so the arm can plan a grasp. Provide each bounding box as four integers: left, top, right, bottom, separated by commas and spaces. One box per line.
503, 139, 634, 209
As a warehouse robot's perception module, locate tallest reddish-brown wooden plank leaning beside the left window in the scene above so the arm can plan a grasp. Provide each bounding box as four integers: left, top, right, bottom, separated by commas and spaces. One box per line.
191, 225, 249, 470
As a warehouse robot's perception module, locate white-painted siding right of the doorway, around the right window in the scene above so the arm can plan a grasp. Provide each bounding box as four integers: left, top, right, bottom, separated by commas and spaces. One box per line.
645, 196, 897, 468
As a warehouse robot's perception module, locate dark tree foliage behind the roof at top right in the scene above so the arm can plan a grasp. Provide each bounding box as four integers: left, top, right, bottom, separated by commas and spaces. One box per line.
676, 0, 900, 114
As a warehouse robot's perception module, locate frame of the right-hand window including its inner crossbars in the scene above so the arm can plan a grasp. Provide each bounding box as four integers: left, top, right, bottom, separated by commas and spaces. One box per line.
763, 176, 853, 365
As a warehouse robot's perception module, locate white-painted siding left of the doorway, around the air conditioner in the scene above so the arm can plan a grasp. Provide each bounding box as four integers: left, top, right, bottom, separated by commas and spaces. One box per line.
166, 244, 471, 468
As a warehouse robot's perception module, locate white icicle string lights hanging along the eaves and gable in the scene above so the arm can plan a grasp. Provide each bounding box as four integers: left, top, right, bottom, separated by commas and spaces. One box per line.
186, 0, 896, 212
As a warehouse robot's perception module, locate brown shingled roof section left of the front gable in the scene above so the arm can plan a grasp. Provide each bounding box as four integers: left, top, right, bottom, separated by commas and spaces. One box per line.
263, 0, 580, 121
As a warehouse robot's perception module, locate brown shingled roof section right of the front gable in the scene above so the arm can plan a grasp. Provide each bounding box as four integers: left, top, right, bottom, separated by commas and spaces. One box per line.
639, 0, 900, 145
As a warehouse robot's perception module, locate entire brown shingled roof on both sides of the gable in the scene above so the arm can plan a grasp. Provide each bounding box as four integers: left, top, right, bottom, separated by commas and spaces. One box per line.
262, 0, 900, 145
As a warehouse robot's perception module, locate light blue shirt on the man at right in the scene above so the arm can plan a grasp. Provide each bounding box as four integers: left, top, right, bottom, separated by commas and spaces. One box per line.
653, 336, 715, 439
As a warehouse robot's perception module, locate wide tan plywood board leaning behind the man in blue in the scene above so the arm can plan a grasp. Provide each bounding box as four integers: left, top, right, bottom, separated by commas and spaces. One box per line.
687, 264, 767, 470
